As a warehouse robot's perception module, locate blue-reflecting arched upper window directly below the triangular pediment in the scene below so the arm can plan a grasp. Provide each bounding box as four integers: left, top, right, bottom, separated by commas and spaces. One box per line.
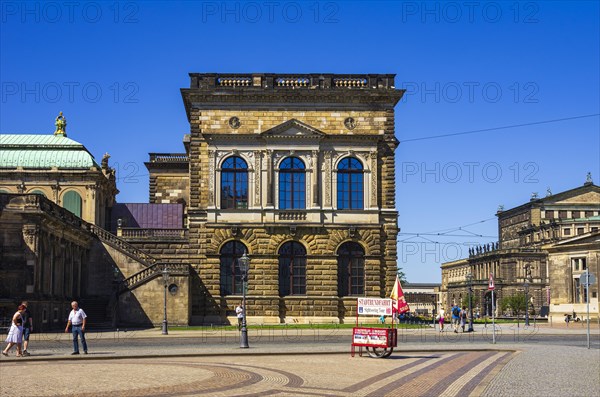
279, 157, 306, 210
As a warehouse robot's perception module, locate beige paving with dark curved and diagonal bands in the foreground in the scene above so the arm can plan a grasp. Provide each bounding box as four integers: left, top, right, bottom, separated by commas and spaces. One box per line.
1, 351, 514, 397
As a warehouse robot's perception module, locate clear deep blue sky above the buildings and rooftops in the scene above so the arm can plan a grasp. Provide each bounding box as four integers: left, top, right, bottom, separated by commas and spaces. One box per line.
0, 0, 600, 282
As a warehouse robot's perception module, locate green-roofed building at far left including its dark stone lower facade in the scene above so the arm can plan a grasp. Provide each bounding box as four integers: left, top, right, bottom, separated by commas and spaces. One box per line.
0, 113, 118, 330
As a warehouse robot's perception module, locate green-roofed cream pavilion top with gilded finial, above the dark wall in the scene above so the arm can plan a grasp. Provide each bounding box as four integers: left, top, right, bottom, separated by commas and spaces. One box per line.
0, 112, 118, 227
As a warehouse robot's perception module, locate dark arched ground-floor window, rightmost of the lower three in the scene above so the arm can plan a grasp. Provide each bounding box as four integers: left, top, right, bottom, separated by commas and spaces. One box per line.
338, 242, 365, 297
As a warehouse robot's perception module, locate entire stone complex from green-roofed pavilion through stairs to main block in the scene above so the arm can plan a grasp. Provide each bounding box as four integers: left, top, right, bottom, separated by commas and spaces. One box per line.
0, 74, 403, 325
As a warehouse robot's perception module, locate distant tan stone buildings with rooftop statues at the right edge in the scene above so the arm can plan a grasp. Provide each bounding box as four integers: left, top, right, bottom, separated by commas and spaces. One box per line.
441, 181, 600, 319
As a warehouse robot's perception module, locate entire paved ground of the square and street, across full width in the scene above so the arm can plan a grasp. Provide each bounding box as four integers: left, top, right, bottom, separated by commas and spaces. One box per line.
0, 327, 600, 397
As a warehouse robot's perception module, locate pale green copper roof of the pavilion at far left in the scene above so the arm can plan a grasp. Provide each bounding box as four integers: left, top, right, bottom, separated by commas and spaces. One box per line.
0, 134, 99, 169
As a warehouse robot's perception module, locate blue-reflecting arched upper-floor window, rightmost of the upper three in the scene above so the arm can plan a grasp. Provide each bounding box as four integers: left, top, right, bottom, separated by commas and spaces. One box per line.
337, 157, 364, 210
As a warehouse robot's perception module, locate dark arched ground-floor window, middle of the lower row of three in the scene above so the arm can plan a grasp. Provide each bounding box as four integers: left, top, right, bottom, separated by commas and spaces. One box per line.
279, 241, 306, 296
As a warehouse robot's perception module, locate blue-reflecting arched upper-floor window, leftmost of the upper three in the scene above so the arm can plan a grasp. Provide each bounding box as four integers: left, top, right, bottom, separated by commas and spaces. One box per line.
221, 156, 248, 209
